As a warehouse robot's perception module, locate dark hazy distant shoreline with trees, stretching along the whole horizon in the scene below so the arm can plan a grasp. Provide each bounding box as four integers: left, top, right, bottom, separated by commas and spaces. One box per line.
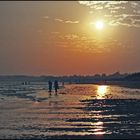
0, 73, 140, 89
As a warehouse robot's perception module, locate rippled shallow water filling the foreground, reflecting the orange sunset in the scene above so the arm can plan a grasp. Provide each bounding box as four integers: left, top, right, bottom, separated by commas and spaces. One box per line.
0, 82, 140, 139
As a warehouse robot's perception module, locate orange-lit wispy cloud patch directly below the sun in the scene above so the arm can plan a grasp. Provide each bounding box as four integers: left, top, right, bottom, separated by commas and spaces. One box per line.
50, 33, 124, 53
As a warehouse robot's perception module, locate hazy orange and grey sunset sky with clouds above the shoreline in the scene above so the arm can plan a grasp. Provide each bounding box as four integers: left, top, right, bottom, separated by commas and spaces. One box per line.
0, 1, 140, 75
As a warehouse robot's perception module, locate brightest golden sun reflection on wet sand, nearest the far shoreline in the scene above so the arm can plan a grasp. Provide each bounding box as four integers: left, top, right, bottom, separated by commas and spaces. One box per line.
97, 85, 109, 99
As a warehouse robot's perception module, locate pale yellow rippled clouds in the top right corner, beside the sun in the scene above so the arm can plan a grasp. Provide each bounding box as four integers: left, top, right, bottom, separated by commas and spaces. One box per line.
79, 1, 140, 27
